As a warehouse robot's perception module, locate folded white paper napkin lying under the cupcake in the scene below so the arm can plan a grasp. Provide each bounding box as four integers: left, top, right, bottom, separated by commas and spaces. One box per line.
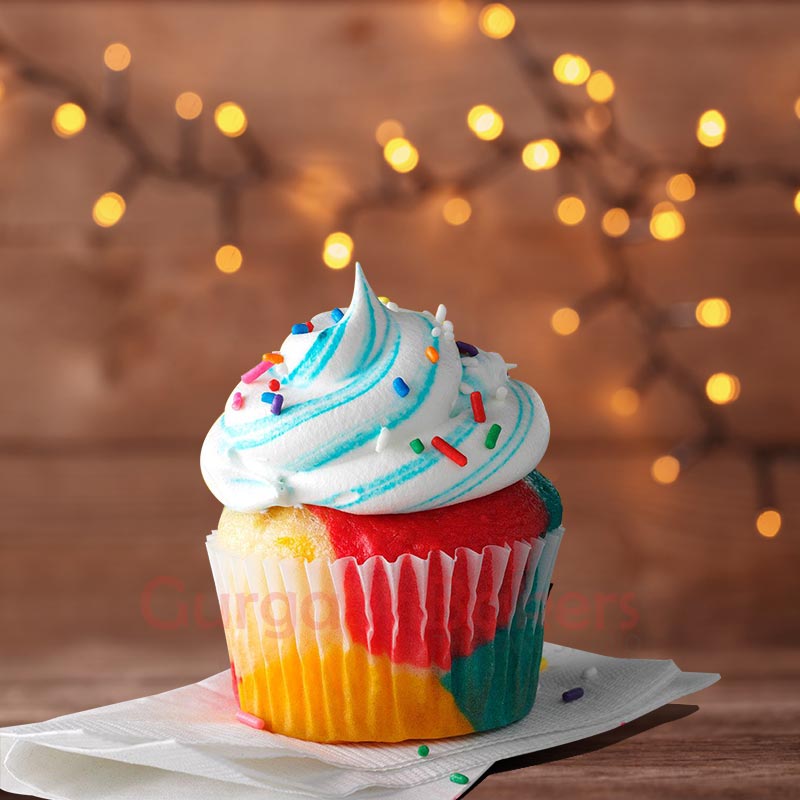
0, 644, 719, 800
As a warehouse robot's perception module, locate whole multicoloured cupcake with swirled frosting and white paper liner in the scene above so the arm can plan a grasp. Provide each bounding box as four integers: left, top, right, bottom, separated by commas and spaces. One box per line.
201, 265, 563, 742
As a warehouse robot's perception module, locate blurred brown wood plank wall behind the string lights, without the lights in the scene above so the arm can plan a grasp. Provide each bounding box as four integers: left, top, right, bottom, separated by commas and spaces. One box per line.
0, 0, 800, 797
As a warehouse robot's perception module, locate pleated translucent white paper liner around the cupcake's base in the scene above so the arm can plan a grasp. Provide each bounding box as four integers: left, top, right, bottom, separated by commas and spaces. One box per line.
207, 528, 563, 741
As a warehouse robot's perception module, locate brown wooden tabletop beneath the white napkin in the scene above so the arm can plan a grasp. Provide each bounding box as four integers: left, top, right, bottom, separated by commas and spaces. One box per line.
0, 644, 800, 800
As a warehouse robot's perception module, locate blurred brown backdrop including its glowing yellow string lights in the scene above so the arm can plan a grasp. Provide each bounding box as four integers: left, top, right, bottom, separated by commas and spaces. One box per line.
0, 0, 800, 736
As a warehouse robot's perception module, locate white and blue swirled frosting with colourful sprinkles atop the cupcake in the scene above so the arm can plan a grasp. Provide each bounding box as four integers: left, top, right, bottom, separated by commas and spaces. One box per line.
200, 265, 550, 514
